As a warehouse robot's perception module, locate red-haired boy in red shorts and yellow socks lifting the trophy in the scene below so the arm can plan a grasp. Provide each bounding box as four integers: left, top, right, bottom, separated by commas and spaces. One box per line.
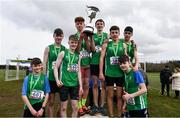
74, 17, 92, 115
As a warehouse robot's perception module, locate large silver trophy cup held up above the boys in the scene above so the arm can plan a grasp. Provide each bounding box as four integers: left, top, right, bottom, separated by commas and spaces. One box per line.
83, 6, 99, 36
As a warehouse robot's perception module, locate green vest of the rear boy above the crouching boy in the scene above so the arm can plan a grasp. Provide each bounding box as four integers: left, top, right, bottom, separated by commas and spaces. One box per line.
120, 39, 135, 63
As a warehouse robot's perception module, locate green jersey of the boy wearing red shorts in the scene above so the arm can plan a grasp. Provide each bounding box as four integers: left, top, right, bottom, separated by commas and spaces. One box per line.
75, 32, 91, 67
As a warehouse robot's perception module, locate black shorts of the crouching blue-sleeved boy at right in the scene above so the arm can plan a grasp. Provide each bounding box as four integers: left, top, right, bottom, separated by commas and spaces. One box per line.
129, 108, 149, 118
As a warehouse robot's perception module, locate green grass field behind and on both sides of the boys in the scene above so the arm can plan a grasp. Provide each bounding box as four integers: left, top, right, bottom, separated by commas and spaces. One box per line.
0, 70, 180, 117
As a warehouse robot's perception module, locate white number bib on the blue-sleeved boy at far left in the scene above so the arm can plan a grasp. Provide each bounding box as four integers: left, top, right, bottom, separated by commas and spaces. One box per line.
30, 89, 44, 99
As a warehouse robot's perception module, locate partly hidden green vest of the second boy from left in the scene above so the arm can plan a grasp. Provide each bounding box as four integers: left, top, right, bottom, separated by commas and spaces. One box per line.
47, 44, 66, 81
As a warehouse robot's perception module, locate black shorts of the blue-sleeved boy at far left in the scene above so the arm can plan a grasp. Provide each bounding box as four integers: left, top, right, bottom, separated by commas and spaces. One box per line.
23, 103, 45, 117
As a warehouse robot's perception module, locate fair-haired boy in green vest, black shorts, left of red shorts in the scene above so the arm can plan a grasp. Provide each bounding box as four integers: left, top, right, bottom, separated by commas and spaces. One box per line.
54, 35, 83, 117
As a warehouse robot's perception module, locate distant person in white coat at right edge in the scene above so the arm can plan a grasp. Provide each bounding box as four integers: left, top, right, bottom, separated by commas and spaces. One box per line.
171, 67, 180, 98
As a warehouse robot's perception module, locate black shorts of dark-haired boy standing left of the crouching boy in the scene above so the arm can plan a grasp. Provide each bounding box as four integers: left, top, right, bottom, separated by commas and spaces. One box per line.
105, 76, 124, 87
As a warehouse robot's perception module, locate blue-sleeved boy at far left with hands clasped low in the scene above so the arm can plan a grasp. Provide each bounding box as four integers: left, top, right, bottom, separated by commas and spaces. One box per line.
22, 58, 50, 117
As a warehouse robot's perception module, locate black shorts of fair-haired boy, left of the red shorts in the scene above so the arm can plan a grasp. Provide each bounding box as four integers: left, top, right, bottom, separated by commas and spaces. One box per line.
60, 86, 79, 102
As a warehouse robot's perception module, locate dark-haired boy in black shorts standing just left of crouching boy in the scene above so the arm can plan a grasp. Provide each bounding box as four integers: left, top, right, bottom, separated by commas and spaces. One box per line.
99, 26, 127, 117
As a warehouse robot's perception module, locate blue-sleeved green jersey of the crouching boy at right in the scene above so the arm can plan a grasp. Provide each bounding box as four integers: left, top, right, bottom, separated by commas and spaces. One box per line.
124, 69, 147, 111
